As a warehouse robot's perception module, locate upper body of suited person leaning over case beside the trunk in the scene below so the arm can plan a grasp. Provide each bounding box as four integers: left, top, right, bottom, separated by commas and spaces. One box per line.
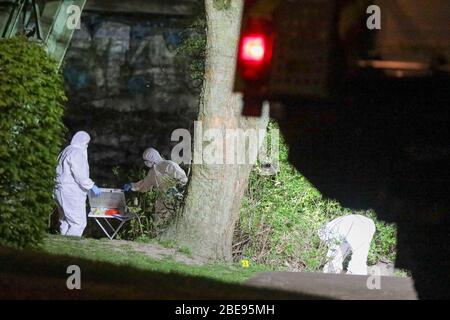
123, 148, 188, 193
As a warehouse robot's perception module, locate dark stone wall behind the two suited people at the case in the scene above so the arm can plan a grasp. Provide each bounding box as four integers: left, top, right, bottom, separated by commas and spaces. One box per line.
64, 12, 198, 185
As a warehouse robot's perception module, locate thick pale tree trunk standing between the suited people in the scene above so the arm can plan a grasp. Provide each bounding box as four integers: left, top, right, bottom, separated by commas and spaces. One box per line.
163, 0, 268, 260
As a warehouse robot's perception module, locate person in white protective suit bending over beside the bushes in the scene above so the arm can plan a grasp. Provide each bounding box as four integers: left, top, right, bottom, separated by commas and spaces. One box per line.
319, 214, 375, 275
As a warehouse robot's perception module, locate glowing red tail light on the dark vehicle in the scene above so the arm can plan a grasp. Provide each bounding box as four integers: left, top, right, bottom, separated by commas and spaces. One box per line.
238, 19, 273, 81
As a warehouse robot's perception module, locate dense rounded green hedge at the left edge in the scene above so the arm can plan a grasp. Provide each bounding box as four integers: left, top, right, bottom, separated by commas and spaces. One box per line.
0, 37, 66, 247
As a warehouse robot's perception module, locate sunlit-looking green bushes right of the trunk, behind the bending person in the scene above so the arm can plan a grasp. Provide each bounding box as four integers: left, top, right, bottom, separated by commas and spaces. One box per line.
234, 124, 396, 271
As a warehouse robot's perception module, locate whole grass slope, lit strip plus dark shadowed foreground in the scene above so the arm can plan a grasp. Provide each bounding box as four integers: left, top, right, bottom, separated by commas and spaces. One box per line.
0, 236, 317, 300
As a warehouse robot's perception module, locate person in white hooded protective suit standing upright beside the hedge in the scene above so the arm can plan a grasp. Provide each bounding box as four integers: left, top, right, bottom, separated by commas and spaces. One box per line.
54, 131, 101, 237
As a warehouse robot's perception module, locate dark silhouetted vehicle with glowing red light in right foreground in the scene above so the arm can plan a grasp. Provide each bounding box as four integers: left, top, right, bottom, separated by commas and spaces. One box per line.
235, 0, 450, 299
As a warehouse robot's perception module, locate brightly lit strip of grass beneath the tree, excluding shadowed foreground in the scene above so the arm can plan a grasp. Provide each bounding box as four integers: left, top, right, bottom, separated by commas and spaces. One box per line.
41, 235, 273, 283
